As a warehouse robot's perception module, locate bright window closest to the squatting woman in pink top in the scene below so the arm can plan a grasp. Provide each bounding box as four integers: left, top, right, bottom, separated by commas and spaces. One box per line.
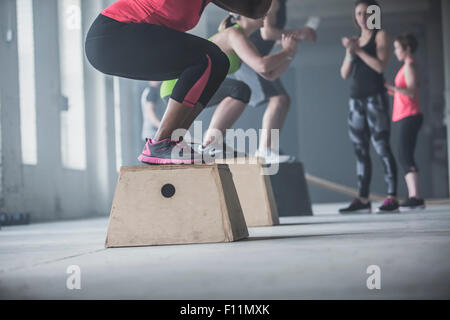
58, 0, 86, 170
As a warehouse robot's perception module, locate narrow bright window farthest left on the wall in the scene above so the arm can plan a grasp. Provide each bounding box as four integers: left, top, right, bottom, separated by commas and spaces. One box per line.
16, 0, 37, 165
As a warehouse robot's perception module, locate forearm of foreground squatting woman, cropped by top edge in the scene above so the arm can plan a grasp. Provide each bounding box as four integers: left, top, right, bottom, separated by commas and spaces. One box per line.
211, 0, 272, 19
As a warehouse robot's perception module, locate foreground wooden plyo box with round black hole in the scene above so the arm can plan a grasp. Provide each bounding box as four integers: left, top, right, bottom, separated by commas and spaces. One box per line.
105, 165, 248, 248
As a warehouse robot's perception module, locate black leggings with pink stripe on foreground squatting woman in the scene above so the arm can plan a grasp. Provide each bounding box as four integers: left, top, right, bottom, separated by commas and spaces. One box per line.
86, 15, 229, 107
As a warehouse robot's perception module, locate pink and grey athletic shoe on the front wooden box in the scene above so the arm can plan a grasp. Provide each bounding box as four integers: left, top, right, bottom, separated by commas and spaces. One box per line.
138, 139, 201, 164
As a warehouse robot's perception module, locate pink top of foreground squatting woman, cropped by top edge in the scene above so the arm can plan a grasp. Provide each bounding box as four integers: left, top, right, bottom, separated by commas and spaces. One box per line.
102, 0, 211, 32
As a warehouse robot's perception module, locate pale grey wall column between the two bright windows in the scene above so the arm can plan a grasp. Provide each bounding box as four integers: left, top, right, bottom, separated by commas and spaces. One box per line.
31, 0, 63, 221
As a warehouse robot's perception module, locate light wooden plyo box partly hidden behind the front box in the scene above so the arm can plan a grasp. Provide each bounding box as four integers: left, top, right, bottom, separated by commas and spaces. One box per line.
216, 158, 280, 227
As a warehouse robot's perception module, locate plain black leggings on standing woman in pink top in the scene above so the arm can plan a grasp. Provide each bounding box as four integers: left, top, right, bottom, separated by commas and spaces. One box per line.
397, 114, 423, 175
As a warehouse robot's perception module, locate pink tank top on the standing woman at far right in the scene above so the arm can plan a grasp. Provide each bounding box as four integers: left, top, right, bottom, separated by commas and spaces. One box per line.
392, 65, 421, 121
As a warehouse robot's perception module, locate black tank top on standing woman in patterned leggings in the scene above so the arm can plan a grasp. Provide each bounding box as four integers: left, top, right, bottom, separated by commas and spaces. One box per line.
350, 30, 386, 99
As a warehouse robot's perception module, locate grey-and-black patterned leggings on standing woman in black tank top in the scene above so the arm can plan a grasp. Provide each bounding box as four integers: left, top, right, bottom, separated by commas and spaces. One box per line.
348, 93, 397, 198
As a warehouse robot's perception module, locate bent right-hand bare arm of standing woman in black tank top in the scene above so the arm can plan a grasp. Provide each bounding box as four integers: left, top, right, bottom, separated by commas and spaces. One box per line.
355, 30, 391, 73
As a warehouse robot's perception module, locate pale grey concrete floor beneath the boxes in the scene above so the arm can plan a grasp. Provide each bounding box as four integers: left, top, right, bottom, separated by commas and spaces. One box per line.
0, 205, 450, 299
